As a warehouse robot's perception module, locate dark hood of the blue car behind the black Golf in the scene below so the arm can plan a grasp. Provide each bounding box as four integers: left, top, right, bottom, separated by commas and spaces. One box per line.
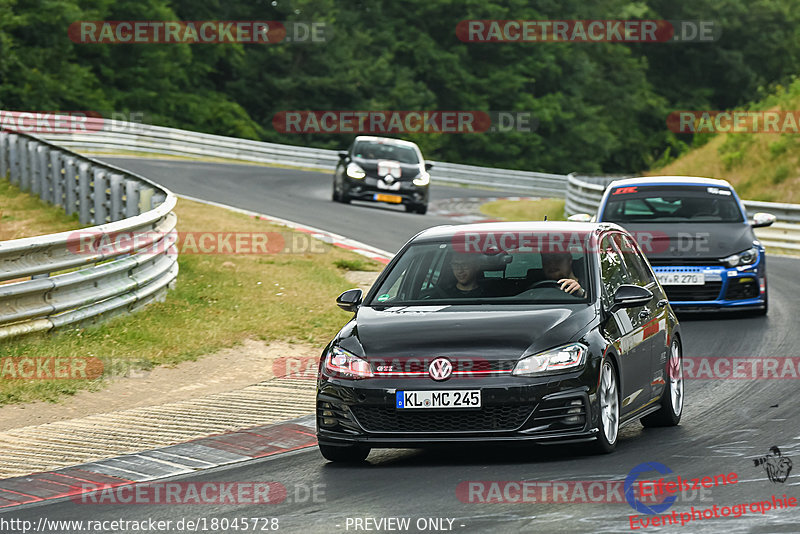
621, 223, 756, 259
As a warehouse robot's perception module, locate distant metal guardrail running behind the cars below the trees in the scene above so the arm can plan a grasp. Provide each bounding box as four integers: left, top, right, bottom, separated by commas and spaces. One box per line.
21, 111, 800, 253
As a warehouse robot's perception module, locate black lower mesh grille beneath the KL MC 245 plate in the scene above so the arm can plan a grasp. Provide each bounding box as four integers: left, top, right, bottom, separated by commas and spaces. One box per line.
351, 405, 533, 433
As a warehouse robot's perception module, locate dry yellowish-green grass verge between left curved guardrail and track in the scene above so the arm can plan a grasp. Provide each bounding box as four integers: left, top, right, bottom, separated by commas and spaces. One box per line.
0, 191, 381, 404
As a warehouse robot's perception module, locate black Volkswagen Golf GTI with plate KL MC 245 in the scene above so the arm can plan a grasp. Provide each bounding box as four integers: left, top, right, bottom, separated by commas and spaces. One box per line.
317, 222, 683, 461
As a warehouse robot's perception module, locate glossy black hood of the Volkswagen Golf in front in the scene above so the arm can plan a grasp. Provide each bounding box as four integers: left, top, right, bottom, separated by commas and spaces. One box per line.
340, 304, 595, 360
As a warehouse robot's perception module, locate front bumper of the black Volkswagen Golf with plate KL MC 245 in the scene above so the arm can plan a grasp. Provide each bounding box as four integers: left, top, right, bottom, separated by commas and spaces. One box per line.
317, 377, 598, 447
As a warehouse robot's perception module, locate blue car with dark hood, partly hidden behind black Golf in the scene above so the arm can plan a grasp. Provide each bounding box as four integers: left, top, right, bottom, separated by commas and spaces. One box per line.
596, 176, 775, 314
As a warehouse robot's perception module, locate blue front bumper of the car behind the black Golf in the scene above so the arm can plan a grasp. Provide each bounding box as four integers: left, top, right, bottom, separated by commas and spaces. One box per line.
653, 262, 767, 311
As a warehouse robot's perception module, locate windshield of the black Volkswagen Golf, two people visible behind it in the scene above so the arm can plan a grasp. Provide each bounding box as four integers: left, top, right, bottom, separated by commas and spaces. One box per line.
367, 241, 590, 306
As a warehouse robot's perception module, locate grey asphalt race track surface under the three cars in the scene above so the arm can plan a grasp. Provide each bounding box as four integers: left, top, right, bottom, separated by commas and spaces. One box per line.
0, 159, 800, 534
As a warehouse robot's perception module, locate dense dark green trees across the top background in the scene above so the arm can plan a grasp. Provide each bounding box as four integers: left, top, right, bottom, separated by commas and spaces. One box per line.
0, 0, 800, 172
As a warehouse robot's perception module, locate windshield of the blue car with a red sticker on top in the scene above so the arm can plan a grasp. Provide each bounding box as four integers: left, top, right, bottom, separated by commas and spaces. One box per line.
602, 185, 744, 223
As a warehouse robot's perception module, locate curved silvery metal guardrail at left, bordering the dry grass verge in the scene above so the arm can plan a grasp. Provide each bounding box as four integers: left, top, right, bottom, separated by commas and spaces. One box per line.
0, 127, 178, 339
